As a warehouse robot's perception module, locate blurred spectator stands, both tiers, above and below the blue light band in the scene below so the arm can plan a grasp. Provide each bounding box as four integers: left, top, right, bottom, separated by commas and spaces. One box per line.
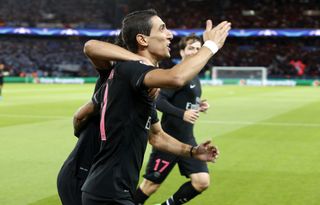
0, 0, 320, 78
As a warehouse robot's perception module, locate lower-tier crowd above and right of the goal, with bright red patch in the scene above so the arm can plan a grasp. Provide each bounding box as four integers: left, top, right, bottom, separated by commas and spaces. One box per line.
212, 38, 320, 78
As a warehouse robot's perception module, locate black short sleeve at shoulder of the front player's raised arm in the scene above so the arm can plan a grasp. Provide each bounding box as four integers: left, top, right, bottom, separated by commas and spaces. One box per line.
117, 61, 154, 90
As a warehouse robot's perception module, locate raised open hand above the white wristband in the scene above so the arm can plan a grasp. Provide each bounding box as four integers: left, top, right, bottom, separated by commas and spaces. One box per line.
203, 20, 231, 49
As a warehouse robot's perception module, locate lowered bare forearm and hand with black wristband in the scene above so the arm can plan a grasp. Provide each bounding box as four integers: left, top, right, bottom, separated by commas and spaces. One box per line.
149, 122, 219, 162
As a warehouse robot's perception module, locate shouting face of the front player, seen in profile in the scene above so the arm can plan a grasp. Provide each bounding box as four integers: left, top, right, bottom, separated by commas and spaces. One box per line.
147, 16, 173, 60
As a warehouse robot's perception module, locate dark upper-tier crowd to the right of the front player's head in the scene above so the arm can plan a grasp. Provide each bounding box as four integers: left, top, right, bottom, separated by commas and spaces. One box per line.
139, 0, 320, 29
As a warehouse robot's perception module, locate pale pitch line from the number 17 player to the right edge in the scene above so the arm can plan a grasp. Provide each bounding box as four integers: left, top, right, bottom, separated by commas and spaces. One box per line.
199, 120, 320, 127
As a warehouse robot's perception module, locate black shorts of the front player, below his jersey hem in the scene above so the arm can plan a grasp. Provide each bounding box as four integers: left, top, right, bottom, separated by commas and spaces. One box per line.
82, 192, 134, 205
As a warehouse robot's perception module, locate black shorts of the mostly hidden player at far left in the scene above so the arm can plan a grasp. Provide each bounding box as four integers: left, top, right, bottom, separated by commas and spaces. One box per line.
57, 164, 85, 205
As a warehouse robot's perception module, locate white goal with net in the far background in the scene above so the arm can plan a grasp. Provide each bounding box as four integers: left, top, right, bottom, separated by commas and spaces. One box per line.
212, 66, 267, 85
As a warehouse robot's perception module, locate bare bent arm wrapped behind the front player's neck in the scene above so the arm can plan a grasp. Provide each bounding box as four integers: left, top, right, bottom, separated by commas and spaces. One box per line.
83, 40, 151, 69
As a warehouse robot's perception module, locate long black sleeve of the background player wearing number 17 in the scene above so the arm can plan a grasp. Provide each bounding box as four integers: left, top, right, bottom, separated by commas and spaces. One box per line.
156, 89, 185, 119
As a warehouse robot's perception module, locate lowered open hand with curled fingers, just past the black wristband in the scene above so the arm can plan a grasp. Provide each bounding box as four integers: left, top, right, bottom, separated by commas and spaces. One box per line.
192, 140, 219, 162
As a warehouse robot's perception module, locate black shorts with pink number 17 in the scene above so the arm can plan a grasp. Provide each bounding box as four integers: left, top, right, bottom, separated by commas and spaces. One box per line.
143, 137, 209, 184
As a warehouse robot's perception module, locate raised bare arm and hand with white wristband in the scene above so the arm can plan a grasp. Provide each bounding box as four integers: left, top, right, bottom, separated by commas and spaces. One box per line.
143, 20, 231, 88
